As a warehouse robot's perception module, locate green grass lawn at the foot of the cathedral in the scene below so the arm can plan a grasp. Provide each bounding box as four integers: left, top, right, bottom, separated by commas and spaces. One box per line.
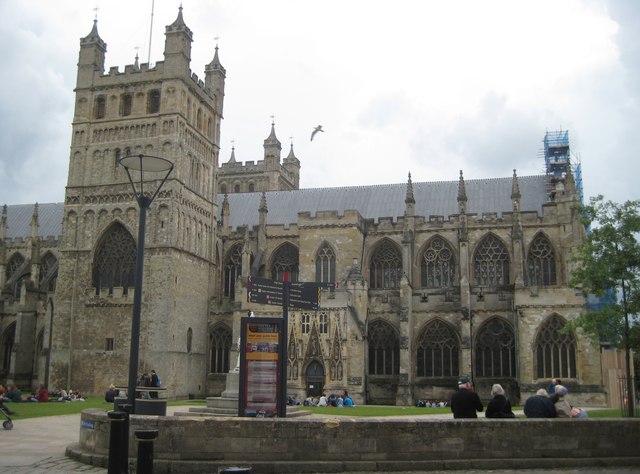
5, 397, 622, 420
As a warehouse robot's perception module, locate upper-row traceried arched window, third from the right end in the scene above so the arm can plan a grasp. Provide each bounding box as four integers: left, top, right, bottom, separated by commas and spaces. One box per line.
420, 237, 456, 288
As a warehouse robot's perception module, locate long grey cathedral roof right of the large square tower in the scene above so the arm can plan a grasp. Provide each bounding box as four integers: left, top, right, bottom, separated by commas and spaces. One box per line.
218, 175, 547, 228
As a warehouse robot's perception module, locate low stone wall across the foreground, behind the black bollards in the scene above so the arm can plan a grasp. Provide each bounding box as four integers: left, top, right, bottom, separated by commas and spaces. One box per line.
67, 410, 640, 473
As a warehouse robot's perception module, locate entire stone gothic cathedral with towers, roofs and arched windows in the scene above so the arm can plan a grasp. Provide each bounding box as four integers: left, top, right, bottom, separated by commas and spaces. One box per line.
0, 8, 608, 405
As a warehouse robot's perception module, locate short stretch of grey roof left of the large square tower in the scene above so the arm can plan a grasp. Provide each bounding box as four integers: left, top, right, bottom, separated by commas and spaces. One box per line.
7, 202, 64, 239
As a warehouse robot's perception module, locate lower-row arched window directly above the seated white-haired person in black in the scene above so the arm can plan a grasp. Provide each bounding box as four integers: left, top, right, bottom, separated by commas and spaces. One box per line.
475, 318, 516, 377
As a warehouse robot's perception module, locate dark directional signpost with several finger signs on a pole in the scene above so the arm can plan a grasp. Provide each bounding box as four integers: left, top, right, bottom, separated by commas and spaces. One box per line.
247, 273, 329, 418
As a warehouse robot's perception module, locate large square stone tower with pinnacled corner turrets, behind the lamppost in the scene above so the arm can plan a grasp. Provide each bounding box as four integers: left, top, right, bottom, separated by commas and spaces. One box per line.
50, 7, 225, 396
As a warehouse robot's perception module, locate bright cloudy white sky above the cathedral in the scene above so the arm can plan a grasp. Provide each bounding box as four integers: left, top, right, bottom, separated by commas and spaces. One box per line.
0, 0, 640, 204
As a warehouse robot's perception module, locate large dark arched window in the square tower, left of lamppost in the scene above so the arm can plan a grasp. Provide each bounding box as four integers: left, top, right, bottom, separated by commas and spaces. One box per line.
93, 224, 136, 294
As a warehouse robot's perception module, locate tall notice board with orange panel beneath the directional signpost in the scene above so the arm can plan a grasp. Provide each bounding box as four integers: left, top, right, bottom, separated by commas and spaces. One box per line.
238, 316, 286, 418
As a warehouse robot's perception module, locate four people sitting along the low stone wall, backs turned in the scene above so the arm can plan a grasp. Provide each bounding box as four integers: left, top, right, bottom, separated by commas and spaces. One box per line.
451, 376, 588, 418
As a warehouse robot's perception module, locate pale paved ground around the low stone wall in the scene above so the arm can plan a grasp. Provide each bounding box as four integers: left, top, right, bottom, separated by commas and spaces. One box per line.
0, 407, 640, 474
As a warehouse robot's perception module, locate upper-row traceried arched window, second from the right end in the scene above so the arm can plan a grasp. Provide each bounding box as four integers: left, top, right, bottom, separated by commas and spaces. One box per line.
473, 234, 509, 287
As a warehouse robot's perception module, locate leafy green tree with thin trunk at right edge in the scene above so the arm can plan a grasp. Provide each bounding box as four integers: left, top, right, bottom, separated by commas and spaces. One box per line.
570, 195, 640, 416
